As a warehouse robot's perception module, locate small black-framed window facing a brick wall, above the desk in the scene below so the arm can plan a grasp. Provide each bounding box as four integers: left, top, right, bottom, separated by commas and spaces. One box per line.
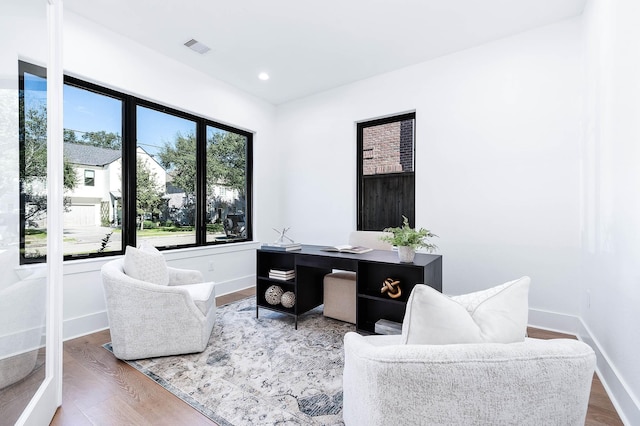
357, 113, 415, 231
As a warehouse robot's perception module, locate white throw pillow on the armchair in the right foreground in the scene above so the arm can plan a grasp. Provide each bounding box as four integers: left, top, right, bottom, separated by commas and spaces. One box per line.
402, 277, 531, 345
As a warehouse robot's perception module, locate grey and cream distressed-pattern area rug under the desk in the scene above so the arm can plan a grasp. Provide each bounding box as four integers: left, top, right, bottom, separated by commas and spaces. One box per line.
105, 297, 355, 426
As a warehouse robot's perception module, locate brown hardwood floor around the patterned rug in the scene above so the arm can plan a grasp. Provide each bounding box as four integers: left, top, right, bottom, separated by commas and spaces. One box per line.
35, 289, 622, 426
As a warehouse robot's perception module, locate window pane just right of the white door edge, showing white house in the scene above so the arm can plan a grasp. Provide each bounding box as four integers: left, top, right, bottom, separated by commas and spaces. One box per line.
63, 79, 124, 257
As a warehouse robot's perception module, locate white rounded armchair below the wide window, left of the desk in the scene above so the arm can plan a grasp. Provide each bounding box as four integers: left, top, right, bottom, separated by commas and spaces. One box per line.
102, 258, 216, 360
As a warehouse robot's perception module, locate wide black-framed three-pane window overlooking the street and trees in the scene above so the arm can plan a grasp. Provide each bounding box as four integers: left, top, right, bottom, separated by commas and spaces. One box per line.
20, 62, 252, 263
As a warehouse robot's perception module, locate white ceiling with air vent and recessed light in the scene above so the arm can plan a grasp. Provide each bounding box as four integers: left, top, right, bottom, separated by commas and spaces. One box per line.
64, 0, 586, 105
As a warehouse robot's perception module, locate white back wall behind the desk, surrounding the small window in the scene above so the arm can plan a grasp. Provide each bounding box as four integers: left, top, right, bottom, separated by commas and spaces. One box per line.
278, 19, 582, 315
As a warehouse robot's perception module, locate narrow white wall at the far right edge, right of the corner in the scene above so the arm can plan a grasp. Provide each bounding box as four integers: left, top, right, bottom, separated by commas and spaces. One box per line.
581, 0, 640, 424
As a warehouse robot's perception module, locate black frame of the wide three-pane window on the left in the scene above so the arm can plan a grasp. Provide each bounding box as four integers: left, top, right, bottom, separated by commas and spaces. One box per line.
18, 61, 253, 264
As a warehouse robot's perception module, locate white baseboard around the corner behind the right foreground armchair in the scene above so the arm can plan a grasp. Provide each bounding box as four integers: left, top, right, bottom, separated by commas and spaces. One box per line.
529, 309, 640, 425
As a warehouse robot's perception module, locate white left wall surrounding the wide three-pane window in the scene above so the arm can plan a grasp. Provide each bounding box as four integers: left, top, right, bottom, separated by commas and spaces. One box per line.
64, 11, 281, 339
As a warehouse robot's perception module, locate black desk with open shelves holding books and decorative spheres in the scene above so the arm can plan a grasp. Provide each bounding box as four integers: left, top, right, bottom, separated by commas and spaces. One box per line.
256, 245, 442, 333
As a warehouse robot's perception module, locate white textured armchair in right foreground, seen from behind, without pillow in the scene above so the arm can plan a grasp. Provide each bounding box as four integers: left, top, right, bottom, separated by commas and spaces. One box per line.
343, 332, 595, 426
